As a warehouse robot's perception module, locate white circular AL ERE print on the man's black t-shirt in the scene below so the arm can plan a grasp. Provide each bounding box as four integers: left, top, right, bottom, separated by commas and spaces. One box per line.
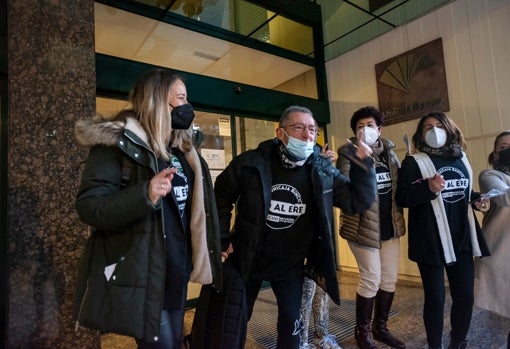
266, 184, 306, 229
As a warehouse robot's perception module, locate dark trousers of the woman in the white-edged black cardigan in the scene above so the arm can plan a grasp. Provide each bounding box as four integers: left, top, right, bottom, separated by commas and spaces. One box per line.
418, 252, 474, 348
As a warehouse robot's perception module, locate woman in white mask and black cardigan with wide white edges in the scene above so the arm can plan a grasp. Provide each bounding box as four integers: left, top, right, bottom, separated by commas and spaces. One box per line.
397, 113, 488, 349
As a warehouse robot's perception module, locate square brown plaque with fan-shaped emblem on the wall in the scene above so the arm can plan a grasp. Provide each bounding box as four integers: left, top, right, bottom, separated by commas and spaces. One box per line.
375, 38, 450, 125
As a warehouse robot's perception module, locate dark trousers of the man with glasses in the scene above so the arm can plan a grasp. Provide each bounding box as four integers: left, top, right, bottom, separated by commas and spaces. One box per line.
246, 274, 303, 349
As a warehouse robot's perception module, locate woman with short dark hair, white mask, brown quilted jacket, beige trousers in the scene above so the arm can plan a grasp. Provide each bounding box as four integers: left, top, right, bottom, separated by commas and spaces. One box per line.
337, 107, 405, 349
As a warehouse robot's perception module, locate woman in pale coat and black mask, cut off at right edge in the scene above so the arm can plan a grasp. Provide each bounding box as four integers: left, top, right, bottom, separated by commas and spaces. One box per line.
475, 130, 510, 348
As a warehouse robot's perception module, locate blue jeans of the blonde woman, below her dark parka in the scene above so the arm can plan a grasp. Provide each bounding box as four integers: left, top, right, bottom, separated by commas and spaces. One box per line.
136, 308, 184, 349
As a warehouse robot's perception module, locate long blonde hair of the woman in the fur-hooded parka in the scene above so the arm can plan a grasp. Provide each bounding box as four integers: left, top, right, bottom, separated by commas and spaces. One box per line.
129, 69, 193, 161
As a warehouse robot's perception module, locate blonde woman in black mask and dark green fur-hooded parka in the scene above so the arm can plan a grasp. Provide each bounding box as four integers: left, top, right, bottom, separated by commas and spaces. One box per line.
75, 70, 222, 349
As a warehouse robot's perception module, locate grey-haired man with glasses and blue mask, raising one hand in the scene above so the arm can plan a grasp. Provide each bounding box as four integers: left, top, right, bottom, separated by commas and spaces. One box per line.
215, 106, 376, 349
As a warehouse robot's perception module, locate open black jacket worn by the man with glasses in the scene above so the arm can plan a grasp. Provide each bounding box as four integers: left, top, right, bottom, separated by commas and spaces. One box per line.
215, 139, 376, 303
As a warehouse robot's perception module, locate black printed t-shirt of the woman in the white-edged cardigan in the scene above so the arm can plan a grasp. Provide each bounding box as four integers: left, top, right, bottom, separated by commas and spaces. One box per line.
430, 155, 471, 251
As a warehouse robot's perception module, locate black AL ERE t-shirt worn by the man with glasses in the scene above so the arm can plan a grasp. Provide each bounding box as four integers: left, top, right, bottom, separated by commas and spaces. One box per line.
251, 153, 316, 280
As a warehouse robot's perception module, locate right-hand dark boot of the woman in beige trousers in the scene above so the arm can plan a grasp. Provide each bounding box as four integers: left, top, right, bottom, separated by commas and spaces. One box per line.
372, 290, 406, 349
